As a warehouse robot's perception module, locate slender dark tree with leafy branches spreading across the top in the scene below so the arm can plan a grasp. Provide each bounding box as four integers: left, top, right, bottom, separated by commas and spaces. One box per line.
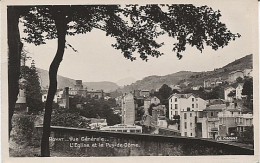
8, 5, 240, 156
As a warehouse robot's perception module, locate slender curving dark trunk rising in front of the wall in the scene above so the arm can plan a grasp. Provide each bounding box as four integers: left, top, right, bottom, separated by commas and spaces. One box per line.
41, 11, 67, 157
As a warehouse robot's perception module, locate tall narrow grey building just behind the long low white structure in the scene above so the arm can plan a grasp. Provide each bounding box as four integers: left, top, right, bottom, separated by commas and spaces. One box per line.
122, 93, 135, 125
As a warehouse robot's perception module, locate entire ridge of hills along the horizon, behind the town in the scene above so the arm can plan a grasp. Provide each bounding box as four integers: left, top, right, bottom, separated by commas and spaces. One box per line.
37, 54, 253, 93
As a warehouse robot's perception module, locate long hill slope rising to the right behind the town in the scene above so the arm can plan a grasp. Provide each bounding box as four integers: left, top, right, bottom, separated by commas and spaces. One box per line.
118, 54, 253, 92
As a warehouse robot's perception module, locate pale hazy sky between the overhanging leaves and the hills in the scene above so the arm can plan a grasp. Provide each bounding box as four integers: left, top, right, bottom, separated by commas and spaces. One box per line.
22, 1, 256, 82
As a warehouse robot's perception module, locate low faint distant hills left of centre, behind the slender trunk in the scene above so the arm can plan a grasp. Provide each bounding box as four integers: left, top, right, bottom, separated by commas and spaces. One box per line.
37, 68, 119, 92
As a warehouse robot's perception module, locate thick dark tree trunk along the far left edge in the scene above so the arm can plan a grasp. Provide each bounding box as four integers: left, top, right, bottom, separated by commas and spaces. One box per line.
7, 6, 23, 138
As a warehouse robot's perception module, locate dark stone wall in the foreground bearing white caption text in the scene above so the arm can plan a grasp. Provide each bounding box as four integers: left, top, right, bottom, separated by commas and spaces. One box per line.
37, 126, 254, 157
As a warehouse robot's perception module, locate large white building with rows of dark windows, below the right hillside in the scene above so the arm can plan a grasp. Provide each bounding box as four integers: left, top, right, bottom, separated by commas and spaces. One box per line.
168, 93, 206, 119
